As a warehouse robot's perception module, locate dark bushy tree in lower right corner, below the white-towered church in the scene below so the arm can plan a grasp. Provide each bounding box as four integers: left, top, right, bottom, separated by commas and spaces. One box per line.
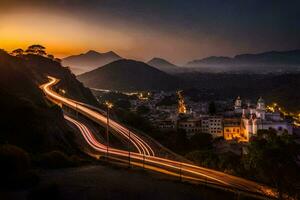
243, 131, 300, 199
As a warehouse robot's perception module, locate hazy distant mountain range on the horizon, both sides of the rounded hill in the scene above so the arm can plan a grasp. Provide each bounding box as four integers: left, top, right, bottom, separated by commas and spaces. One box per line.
62, 50, 300, 75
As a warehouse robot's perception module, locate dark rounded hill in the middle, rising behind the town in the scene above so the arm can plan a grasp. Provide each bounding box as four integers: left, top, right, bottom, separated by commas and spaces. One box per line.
78, 59, 178, 91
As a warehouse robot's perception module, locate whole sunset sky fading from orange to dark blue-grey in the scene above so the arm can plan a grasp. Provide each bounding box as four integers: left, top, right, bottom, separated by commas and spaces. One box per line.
0, 0, 300, 64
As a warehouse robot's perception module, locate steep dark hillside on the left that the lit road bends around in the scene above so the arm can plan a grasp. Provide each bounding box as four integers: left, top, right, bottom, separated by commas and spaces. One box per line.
0, 50, 96, 154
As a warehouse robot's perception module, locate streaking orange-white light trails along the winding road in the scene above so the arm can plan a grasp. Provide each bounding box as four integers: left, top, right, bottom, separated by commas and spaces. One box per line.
41, 77, 277, 198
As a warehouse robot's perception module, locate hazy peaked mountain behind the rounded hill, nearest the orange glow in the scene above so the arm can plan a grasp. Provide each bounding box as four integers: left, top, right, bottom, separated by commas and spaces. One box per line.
62, 50, 121, 74
